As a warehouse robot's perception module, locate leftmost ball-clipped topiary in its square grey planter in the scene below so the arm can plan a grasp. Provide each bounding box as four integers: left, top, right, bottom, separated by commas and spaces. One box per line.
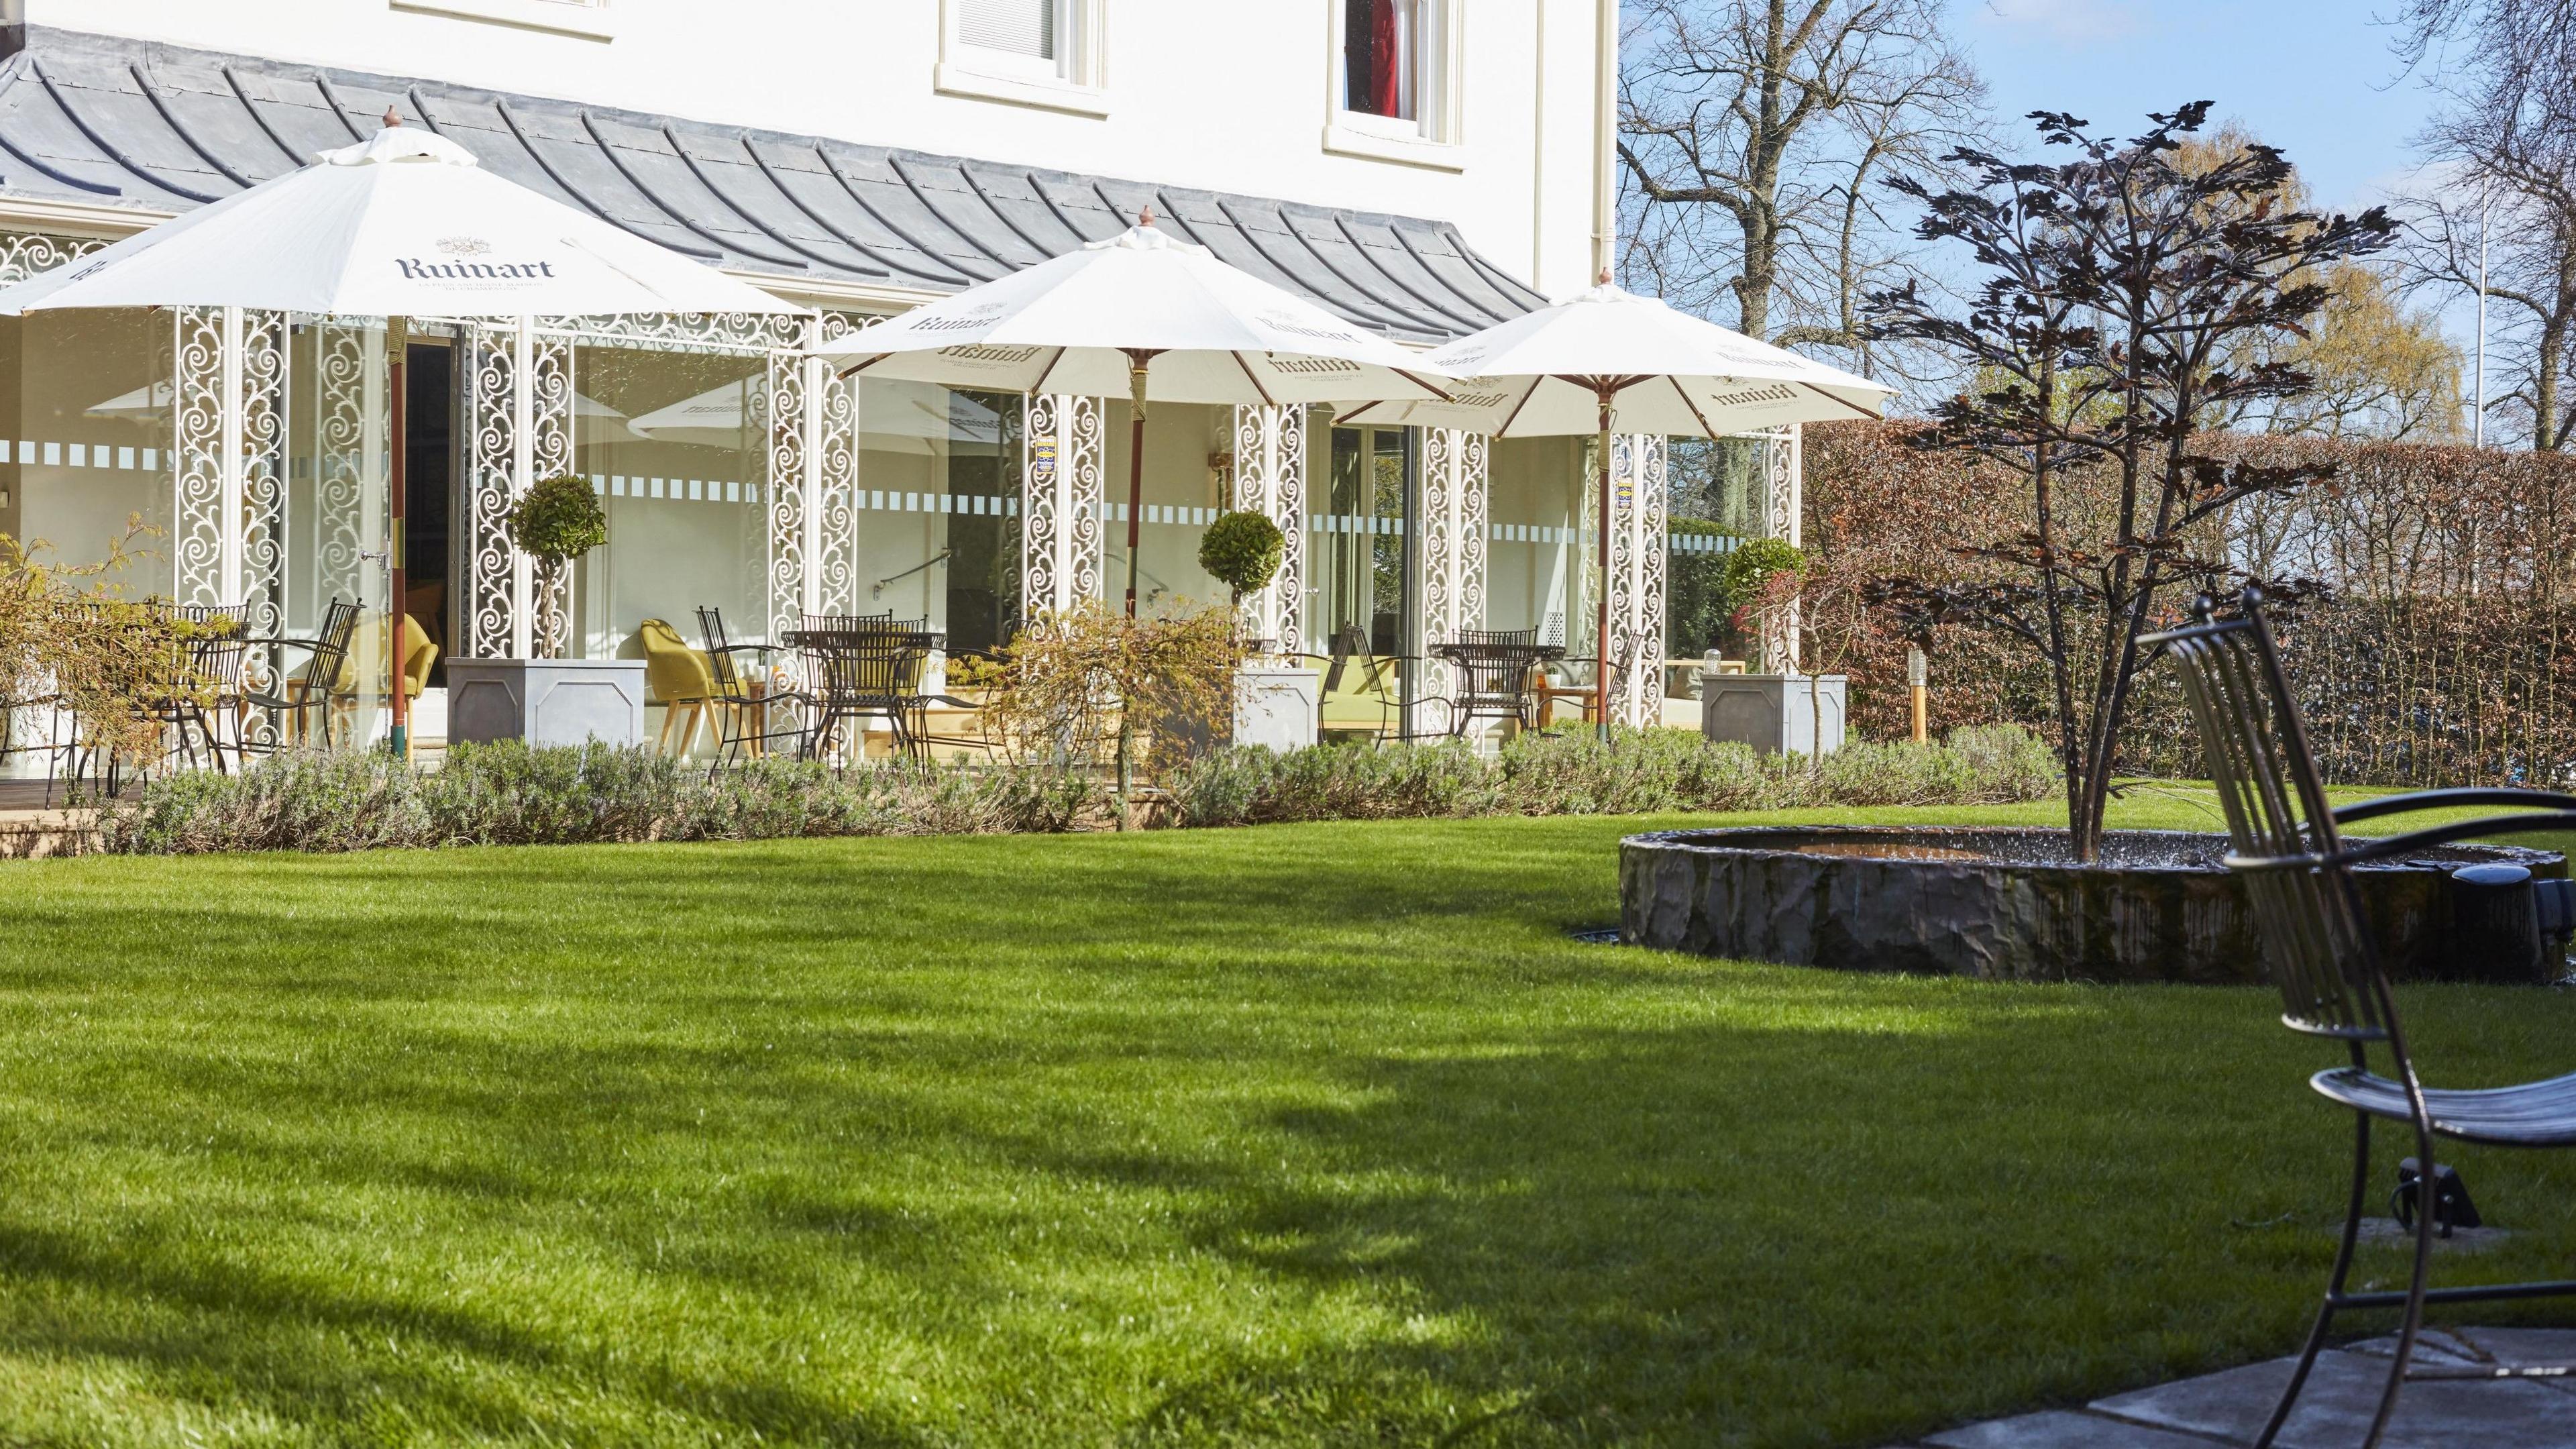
448, 474, 644, 745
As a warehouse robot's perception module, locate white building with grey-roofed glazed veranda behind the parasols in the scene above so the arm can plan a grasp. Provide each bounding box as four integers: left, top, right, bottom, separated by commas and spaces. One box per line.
0, 0, 1793, 730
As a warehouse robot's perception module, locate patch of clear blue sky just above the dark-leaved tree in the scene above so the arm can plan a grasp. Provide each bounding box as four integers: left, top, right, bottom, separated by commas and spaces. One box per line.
1953, 0, 2432, 209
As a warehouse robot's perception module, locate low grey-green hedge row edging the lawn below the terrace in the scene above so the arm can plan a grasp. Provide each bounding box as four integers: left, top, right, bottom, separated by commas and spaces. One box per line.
101, 724, 2061, 856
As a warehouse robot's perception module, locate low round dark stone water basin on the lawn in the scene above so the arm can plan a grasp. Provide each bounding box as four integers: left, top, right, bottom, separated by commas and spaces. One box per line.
1620, 825, 2568, 982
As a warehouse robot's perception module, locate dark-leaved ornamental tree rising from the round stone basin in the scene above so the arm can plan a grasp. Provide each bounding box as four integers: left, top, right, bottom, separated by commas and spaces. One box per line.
1870, 101, 2396, 861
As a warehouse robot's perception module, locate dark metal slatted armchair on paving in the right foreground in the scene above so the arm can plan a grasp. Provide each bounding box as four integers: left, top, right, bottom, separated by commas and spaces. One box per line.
2141, 588, 2576, 1449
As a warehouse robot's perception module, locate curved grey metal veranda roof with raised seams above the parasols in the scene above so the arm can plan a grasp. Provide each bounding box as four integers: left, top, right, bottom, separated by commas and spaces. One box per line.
0, 25, 1543, 337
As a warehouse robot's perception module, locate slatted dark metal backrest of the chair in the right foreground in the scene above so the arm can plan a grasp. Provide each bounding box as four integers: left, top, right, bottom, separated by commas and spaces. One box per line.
2141, 588, 2391, 1042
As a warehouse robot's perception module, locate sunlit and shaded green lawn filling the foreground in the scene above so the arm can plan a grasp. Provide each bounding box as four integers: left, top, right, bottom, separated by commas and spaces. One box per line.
0, 799, 2576, 1446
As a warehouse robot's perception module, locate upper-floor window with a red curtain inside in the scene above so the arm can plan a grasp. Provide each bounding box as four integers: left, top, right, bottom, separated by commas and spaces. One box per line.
1324, 0, 1466, 168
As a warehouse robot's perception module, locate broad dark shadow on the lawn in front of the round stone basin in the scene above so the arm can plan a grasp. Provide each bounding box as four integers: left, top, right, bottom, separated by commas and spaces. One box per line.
983, 985, 2493, 1444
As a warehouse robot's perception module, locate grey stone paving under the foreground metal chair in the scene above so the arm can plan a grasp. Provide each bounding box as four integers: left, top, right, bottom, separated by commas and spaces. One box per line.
2092, 1351, 2576, 1449
